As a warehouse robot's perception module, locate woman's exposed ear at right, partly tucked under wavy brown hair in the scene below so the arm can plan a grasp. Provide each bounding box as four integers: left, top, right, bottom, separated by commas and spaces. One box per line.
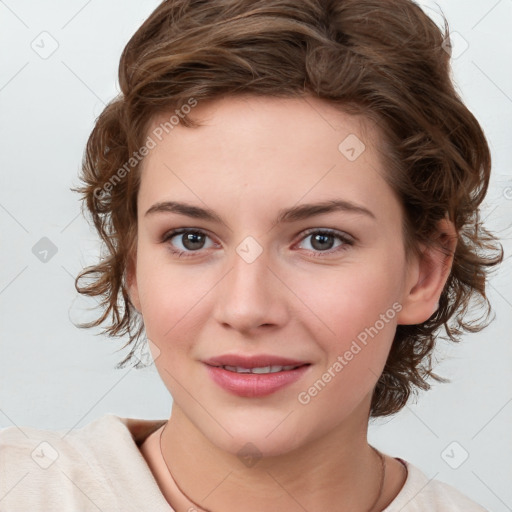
397, 219, 457, 325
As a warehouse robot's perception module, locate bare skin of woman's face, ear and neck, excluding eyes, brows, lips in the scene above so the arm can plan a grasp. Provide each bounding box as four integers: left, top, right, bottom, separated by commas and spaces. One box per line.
128, 96, 456, 512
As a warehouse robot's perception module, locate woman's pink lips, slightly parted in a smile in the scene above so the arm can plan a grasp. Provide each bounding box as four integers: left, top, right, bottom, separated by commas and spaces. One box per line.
204, 354, 310, 398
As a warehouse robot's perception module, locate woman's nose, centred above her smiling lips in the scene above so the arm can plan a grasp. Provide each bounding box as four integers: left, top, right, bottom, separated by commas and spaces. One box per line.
214, 245, 289, 334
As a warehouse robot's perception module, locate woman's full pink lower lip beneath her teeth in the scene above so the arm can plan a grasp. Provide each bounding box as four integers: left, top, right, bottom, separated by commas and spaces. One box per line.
206, 365, 309, 398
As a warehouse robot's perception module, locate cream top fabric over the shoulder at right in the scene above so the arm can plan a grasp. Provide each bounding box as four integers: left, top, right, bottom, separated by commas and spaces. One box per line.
383, 459, 488, 512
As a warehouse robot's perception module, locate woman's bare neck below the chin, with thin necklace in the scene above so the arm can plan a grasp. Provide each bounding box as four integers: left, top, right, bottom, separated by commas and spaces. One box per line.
161, 398, 383, 512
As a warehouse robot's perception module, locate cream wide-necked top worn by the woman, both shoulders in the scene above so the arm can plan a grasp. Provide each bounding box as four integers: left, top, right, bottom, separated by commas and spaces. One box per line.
0, 414, 486, 512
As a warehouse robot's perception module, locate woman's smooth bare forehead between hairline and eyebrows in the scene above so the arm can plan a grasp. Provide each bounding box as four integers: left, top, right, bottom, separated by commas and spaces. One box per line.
140, 96, 396, 230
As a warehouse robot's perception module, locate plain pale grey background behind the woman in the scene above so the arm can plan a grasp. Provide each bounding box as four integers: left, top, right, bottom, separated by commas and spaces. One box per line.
0, 0, 512, 512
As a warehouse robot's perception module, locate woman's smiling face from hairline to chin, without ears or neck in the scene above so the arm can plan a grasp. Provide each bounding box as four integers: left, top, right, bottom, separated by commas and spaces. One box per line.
130, 97, 418, 455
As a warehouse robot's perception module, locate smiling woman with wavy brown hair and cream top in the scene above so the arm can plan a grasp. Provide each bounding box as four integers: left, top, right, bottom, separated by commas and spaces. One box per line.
0, 0, 502, 512
